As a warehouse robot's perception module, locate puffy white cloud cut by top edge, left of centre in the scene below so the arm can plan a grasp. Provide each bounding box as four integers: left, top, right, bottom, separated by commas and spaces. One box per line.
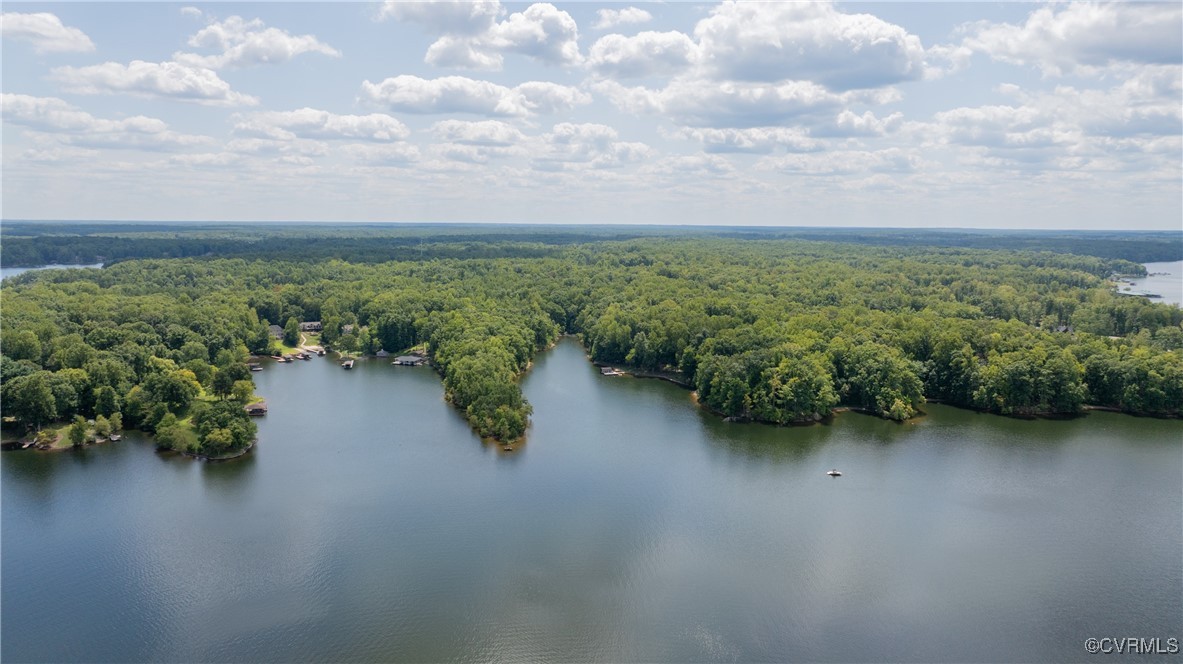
380, 1, 582, 70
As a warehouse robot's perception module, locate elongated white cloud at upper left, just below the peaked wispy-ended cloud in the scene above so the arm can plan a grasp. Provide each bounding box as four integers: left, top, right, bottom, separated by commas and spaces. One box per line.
50, 60, 259, 107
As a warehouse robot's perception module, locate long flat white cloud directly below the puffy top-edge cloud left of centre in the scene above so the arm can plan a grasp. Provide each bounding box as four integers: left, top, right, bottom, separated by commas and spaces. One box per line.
361, 75, 592, 117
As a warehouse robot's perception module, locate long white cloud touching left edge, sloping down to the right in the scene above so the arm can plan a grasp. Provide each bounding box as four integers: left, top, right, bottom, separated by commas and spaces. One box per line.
2, 92, 209, 150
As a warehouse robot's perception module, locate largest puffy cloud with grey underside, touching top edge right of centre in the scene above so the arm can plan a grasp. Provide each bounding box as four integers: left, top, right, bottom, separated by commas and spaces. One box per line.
694, 1, 924, 90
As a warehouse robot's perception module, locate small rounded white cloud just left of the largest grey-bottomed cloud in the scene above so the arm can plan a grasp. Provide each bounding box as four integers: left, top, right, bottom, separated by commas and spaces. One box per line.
587, 31, 698, 78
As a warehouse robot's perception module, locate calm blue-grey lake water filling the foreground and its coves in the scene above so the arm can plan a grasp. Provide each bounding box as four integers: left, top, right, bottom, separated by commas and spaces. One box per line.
0, 340, 1183, 662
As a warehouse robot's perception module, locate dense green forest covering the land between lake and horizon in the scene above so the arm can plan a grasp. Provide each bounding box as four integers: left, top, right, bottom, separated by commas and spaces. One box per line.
0, 231, 1183, 445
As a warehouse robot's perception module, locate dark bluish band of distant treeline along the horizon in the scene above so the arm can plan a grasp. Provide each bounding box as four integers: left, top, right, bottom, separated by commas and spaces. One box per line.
0, 221, 1183, 266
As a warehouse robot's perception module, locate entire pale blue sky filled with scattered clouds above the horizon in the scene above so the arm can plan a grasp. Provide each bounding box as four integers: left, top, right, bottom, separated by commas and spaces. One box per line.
0, 0, 1183, 230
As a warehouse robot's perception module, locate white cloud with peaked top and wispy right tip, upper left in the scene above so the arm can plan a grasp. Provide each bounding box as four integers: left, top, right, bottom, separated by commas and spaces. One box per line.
173, 17, 341, 69
